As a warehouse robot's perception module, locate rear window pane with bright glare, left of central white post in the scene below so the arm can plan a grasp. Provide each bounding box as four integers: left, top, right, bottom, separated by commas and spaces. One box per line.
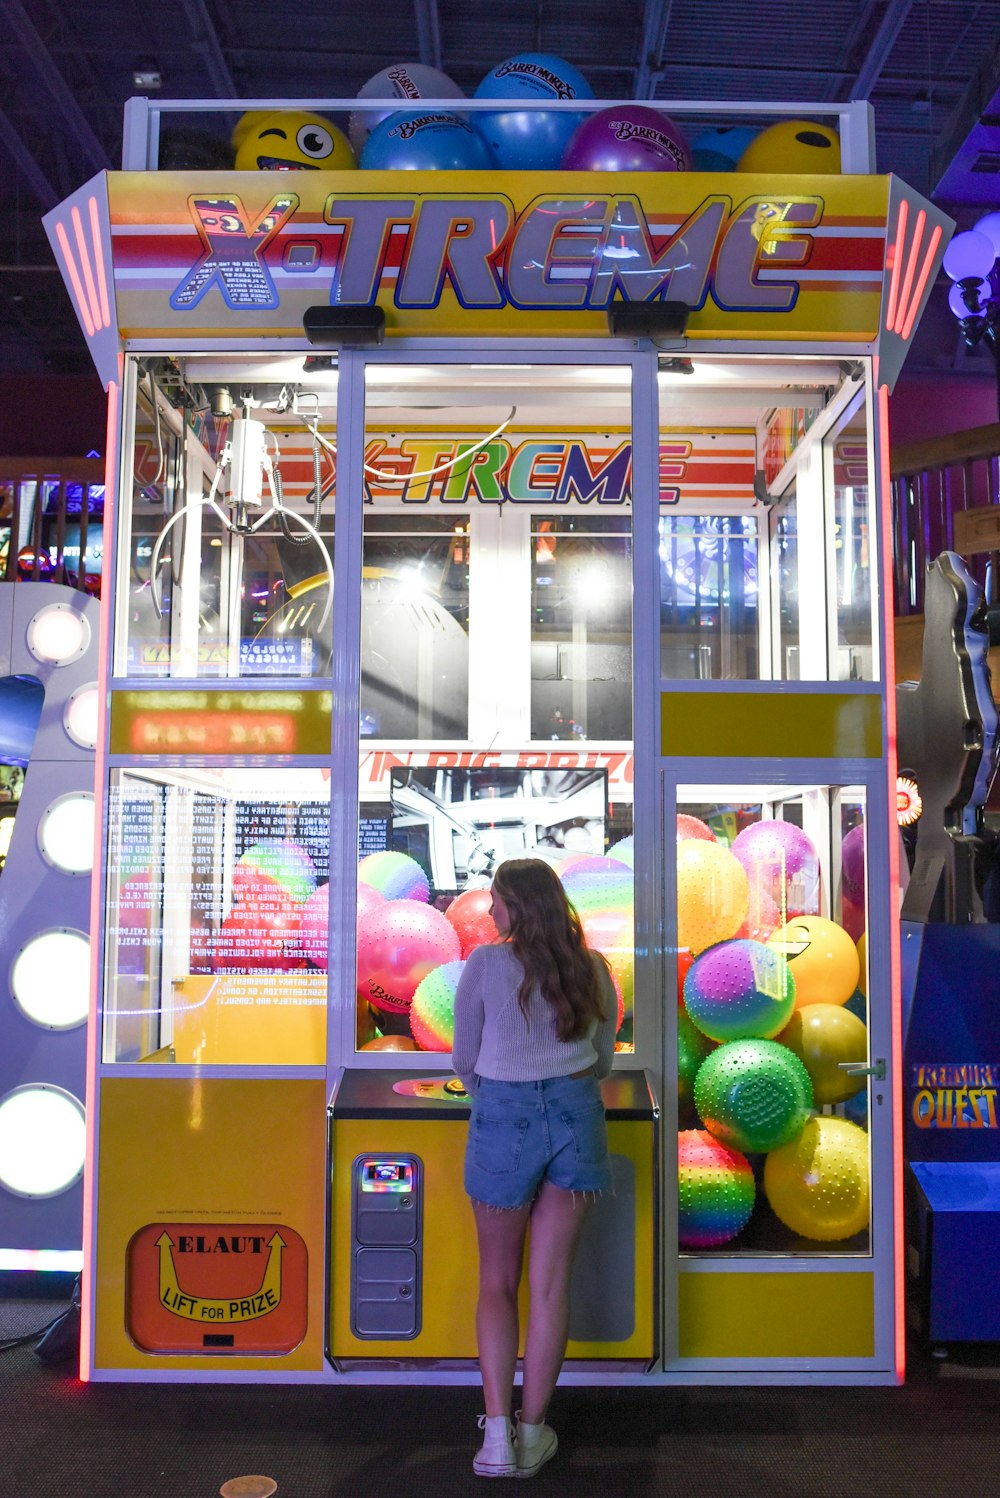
361, 515, 470, 739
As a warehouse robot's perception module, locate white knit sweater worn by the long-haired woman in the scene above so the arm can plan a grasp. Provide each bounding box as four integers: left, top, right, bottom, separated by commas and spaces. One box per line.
452, 944, 618, 1092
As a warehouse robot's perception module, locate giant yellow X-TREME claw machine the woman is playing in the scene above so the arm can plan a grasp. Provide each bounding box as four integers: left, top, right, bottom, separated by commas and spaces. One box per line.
46, 61, 949, 1384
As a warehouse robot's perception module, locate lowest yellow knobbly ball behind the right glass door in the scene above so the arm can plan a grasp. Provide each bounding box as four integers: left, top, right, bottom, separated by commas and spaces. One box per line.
763, 1116, 870, 1243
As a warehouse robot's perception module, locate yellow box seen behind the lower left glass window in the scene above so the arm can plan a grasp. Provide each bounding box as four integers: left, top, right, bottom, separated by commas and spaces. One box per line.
172, 972, 326, 1067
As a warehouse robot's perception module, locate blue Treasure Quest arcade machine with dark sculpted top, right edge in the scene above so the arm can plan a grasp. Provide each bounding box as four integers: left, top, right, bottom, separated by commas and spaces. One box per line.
898, 551, 1000, 1356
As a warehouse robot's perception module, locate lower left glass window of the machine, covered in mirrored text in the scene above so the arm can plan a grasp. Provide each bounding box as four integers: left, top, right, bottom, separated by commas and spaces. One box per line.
105, 768, 329, 1065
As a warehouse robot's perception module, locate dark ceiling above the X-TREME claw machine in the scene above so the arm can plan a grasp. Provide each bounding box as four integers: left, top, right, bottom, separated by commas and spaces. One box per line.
0, 0, 1000, 373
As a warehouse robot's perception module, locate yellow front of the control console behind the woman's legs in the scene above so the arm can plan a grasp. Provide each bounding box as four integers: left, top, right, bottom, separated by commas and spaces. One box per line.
329, 1118, 654, 1359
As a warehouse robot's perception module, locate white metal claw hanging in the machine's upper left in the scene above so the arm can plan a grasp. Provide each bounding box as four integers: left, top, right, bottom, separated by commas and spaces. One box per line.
150, 391, 334, 640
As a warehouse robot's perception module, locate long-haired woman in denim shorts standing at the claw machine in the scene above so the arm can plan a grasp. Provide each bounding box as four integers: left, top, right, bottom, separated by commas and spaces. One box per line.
452, 858, 617, 1477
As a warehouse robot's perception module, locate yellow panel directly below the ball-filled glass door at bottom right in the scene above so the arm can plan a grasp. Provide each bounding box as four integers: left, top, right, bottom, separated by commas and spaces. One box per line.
677, 1270, 874, 1359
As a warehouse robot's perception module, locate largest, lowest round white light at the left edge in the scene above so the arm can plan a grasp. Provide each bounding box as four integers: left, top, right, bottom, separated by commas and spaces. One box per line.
0, 1083, 87, 1197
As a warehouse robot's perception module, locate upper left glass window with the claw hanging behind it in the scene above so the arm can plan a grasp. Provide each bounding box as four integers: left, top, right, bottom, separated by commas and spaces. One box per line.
118, 360, 335, 677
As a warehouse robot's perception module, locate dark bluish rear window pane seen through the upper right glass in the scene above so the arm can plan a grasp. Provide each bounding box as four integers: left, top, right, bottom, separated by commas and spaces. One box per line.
660, 515, 759, 682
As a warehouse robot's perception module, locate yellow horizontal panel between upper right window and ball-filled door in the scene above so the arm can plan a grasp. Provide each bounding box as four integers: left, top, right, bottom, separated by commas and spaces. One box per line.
660, 692, 882, 759
